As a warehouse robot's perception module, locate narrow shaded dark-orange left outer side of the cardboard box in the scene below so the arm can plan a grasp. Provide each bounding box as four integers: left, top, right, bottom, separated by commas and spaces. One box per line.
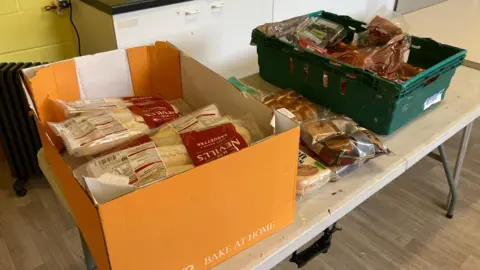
37, 119, 110, 270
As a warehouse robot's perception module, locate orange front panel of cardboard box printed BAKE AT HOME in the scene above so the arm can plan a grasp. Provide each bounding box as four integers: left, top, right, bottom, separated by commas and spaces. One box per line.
99, 127, 299, 270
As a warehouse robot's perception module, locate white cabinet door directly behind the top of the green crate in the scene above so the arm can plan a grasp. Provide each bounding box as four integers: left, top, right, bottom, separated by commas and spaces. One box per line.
273, 0, 372, 21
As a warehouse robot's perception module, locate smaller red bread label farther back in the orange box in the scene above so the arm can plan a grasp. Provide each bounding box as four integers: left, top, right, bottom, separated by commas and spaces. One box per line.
128, 100, 180, 128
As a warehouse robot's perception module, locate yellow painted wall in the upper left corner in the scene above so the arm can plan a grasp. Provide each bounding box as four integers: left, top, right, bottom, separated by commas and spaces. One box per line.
0, 0, 77, 62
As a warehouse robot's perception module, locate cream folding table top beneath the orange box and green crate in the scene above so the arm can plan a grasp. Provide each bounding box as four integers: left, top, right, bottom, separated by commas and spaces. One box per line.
213, 67, 480, 270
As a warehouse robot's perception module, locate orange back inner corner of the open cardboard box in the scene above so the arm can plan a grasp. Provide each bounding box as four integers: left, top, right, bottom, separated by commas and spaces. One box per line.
127, 42, 182, 100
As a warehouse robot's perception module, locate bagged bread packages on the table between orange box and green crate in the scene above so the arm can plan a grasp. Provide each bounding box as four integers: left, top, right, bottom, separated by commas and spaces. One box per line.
229, 78, 390, 197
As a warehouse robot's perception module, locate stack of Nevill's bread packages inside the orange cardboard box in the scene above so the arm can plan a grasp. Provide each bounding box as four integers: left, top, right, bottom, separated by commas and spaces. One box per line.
49, 97, 264, 198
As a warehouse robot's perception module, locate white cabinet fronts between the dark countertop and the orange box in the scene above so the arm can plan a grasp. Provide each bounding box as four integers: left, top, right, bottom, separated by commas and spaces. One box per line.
113, 0, 273, 77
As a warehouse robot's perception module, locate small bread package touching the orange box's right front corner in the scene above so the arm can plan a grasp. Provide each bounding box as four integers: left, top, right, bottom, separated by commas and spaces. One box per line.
296, 145, 337, 196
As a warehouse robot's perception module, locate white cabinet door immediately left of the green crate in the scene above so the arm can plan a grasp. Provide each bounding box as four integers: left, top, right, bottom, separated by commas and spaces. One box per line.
197, 0, 273, 77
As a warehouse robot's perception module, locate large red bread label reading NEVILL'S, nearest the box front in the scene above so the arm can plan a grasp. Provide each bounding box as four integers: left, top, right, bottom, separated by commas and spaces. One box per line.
180, 123, 248, 166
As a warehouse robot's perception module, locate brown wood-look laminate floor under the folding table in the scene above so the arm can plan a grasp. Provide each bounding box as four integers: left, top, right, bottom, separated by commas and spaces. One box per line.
0, 121, 480, 270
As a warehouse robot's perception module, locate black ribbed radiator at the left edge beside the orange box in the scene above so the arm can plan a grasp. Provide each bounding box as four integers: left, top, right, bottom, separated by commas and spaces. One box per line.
0, 63, 41, 196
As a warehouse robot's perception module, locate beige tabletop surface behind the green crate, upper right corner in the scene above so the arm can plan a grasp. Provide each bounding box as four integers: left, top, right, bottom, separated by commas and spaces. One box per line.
405, 0, 480, 69
